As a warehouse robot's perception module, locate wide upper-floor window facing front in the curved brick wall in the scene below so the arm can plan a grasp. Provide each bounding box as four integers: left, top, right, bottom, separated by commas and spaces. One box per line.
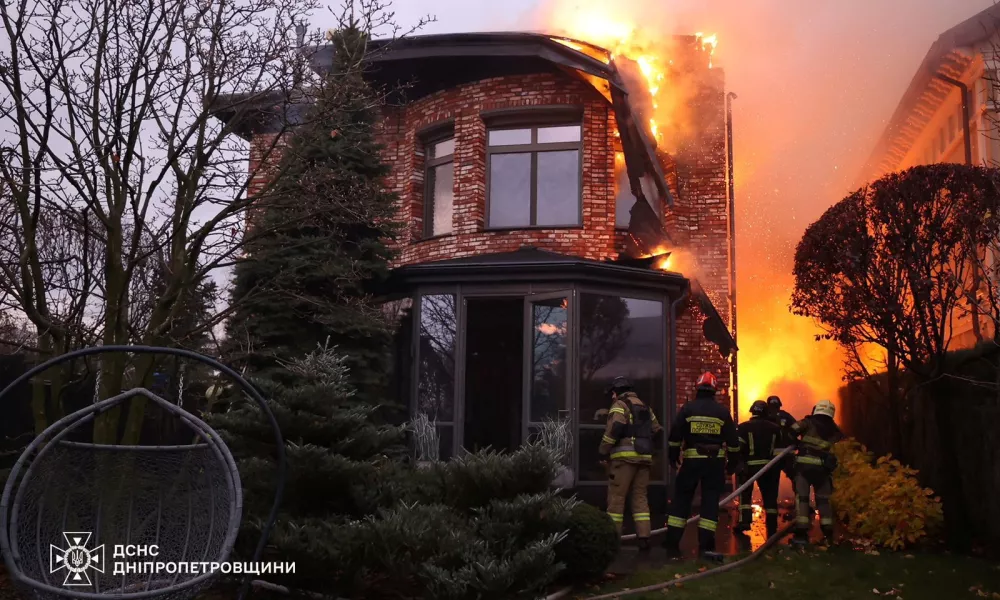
487, 124, 583, 228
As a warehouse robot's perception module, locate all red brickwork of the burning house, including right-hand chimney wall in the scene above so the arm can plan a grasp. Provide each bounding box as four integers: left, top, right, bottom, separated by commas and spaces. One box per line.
250, 54, 729, 414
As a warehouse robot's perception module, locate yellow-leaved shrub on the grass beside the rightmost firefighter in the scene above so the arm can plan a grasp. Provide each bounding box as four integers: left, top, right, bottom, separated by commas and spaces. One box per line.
831, 440, 943, 550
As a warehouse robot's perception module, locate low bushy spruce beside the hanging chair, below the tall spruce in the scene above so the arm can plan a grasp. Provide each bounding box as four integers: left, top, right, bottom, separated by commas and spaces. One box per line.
205, 347, 406, 591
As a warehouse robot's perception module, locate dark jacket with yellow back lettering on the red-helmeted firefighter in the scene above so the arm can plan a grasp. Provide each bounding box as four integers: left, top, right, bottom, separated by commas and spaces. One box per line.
668, 391, 740, 464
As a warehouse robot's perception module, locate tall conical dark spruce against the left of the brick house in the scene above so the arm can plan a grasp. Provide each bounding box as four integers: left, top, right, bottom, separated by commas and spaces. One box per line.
227, 26, 398, 401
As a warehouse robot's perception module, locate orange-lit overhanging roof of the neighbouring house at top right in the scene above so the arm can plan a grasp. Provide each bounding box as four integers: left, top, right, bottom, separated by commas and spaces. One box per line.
858, 4, 1000, 185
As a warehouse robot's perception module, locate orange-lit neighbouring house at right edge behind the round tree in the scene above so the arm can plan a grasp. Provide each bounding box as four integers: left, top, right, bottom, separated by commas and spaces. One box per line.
858, 5, 1000, 349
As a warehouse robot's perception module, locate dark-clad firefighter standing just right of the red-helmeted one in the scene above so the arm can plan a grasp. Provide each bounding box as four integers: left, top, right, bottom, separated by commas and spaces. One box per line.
736, 400, 781, 538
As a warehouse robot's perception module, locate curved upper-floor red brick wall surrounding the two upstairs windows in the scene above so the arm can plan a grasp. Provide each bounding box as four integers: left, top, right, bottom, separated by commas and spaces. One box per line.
379, 73, 622, 265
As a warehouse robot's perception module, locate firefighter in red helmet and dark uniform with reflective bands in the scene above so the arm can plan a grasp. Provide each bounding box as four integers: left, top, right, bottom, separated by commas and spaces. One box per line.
663, 372, 740, 561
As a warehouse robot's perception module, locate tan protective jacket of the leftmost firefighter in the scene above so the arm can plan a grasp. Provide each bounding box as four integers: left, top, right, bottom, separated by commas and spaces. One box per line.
598, 392, 663, 464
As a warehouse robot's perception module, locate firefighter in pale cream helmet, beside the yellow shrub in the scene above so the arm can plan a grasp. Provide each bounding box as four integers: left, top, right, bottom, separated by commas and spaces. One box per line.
791, 400, 844, 544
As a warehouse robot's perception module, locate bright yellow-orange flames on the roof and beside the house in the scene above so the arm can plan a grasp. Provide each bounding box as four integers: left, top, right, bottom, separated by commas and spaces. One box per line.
543, 0, 842, 420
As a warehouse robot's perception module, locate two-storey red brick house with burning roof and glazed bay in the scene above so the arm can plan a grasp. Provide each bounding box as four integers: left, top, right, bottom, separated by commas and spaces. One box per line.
219, 33, 735, 508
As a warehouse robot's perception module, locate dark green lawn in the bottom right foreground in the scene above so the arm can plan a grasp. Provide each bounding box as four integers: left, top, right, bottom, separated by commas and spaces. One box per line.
573, 547, 1000, 600
